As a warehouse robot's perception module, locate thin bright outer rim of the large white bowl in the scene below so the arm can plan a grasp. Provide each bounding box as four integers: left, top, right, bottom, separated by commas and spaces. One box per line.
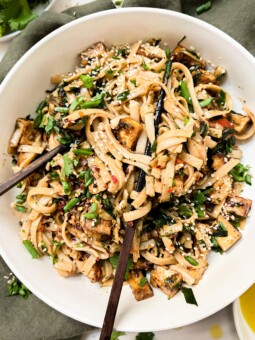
0, 7, 255, 331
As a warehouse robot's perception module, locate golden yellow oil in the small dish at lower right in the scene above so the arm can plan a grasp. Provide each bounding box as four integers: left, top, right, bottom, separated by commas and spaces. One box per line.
239, 284, 255, 333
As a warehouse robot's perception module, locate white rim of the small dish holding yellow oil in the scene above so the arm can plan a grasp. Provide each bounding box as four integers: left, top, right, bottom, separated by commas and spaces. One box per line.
233, 299, 255, 340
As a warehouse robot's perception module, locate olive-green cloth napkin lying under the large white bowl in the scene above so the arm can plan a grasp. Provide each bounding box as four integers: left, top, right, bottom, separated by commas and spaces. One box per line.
0, 0, 255, 340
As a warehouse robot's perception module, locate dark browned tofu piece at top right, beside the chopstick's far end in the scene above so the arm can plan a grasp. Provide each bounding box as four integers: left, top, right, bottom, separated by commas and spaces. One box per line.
172, 44, 206, 69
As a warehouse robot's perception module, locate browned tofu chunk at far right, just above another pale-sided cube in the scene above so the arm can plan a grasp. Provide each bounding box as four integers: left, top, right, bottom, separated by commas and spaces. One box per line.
225, 196, 252, 217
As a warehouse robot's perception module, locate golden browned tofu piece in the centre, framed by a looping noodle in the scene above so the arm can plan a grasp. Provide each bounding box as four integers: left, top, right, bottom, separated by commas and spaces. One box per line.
114, 117, 143, 150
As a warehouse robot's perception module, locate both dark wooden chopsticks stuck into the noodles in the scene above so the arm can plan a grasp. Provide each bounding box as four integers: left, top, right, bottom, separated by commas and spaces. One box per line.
0, 49, 172, 340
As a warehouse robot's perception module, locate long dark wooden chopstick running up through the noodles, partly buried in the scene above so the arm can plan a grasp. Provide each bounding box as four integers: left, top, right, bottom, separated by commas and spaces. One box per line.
100, 56, 172, 340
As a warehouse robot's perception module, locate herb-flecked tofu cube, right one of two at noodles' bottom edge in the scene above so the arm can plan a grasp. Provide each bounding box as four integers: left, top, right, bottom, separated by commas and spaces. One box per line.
150, 266, 182, 298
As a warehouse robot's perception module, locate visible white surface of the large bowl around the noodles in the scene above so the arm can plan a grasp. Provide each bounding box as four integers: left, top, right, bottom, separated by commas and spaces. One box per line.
0, 8, 255, 332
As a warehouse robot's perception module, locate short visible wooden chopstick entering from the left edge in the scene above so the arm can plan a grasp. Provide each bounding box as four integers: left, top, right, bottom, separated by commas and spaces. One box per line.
0, 144, 67, 196
